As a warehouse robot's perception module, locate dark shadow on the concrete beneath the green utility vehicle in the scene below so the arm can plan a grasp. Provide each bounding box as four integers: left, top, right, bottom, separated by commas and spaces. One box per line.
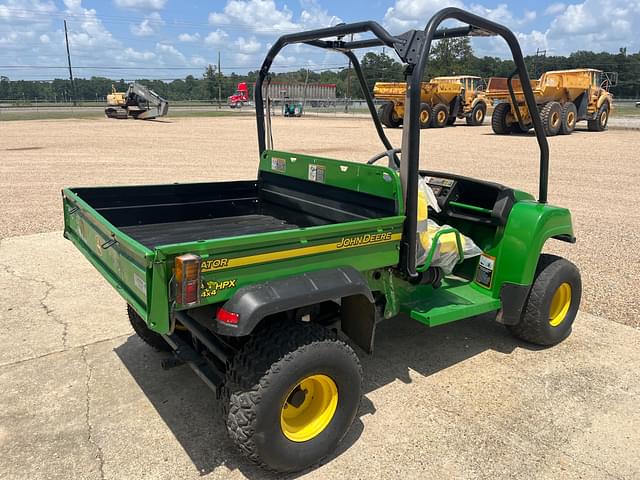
115, 316, 535, 479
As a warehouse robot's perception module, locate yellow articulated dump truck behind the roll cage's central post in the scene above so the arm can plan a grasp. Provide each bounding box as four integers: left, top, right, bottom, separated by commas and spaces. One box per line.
373, 75, 487, 128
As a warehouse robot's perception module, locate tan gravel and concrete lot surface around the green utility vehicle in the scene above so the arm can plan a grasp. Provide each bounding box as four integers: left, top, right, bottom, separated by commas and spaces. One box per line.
0, 117, 640, 479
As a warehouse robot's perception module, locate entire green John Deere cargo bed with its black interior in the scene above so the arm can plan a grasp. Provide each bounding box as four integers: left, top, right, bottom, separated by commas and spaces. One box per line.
63, 151, 404, 333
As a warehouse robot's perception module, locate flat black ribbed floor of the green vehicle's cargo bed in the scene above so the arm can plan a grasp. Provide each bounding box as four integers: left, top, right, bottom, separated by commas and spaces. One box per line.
120, 215, 298, 248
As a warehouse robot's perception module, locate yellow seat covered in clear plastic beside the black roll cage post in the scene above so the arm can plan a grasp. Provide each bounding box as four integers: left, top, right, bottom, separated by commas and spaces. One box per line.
416, 177, 482, 275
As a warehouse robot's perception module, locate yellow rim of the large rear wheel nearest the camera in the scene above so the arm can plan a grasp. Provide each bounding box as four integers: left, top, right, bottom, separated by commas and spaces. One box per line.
280, 374, 338, 442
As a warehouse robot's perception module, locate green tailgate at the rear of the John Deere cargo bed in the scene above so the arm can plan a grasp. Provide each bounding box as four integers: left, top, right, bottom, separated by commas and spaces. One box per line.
62, 189, 154, 320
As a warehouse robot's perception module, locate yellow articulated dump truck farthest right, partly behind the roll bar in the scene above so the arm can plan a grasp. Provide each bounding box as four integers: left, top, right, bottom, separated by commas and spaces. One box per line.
486, 68, 618, 137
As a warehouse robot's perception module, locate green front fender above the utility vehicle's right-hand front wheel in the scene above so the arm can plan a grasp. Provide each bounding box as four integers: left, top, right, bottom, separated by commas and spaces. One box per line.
488, 200, 573, 298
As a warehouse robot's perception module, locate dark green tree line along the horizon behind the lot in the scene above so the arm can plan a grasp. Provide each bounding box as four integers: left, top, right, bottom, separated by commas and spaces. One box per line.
0, 38, 640, 103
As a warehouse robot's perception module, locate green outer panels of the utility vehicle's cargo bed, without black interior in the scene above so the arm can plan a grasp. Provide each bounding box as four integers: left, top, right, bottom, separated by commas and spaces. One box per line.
63, 152, 404, 333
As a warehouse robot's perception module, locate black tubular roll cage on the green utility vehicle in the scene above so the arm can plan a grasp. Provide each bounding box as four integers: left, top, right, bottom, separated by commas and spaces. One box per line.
255, 8, 549, 278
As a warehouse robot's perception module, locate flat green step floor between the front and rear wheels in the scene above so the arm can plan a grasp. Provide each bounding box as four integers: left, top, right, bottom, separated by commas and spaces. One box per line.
400, 279, 501, 327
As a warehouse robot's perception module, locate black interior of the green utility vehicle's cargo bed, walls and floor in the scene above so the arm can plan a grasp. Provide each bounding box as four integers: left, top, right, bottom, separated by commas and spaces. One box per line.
72, 172, 398, 249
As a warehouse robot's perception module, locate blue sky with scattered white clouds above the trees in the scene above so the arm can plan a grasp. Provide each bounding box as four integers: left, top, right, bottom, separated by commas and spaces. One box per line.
0, 0, 640, 79
